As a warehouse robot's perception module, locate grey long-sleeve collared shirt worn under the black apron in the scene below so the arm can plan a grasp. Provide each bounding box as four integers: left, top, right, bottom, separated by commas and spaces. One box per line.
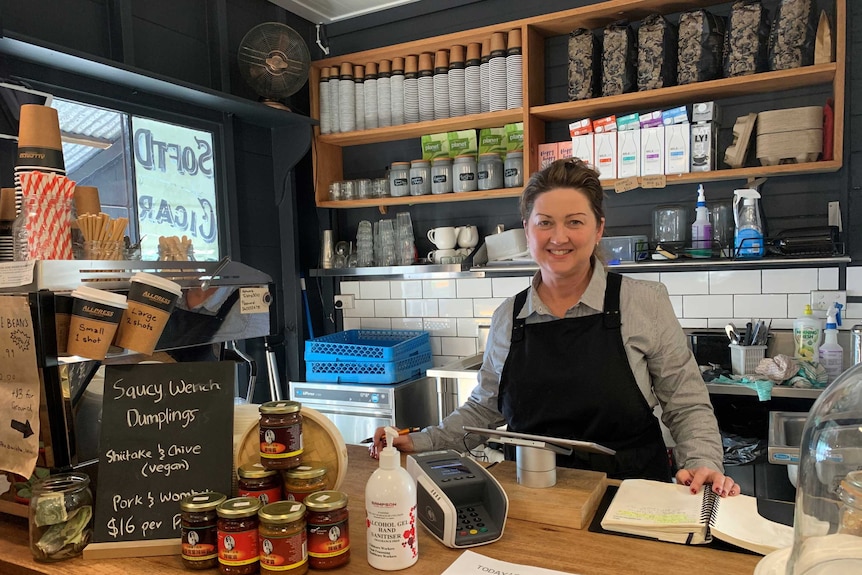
410, 261, 724, 471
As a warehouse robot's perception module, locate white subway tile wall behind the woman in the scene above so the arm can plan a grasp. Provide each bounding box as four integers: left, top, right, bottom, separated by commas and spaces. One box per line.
340, 267, 862, 366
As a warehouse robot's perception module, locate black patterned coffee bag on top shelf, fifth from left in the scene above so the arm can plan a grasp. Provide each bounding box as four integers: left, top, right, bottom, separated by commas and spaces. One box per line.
724, 0, 769, 78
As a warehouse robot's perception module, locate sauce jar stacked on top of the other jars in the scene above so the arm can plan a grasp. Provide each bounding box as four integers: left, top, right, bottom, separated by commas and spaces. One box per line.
260, 401, 302, 469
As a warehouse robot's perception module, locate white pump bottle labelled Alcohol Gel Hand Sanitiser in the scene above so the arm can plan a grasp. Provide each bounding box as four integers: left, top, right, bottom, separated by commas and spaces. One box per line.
365, 427, 419, 571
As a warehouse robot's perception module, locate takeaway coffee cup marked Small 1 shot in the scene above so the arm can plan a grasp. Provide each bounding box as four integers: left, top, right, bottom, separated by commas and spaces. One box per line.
66, 286, 127, 360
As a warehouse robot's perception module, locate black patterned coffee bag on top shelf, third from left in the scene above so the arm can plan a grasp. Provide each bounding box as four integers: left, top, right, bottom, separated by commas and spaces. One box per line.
638, 14, 678, 91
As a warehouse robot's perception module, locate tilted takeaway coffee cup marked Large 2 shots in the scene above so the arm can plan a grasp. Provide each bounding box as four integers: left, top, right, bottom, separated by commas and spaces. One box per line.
116, 272, 183, 355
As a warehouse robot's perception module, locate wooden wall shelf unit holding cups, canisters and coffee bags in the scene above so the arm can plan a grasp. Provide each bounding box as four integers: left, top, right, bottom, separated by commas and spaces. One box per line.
309, 0, 847, 208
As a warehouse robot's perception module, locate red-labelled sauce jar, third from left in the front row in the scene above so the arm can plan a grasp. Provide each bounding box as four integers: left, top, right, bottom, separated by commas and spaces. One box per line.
258, 501, 308, 575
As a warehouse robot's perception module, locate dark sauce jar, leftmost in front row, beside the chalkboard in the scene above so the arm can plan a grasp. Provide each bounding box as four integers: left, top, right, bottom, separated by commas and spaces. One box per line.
180, 491, 227, 570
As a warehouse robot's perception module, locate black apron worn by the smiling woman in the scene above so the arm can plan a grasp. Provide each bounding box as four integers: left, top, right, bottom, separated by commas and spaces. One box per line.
498, 273, 671, 481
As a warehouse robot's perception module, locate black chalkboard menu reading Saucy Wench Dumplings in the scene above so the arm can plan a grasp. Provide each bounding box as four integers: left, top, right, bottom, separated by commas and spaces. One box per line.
94, 362, 236, 542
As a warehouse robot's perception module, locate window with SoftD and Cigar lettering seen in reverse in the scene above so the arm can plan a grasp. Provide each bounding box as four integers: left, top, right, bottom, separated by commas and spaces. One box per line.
51, 97, 222, 261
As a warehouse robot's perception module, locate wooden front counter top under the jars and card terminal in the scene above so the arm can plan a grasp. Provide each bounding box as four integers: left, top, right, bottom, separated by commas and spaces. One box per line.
0, 446, 760, 575
